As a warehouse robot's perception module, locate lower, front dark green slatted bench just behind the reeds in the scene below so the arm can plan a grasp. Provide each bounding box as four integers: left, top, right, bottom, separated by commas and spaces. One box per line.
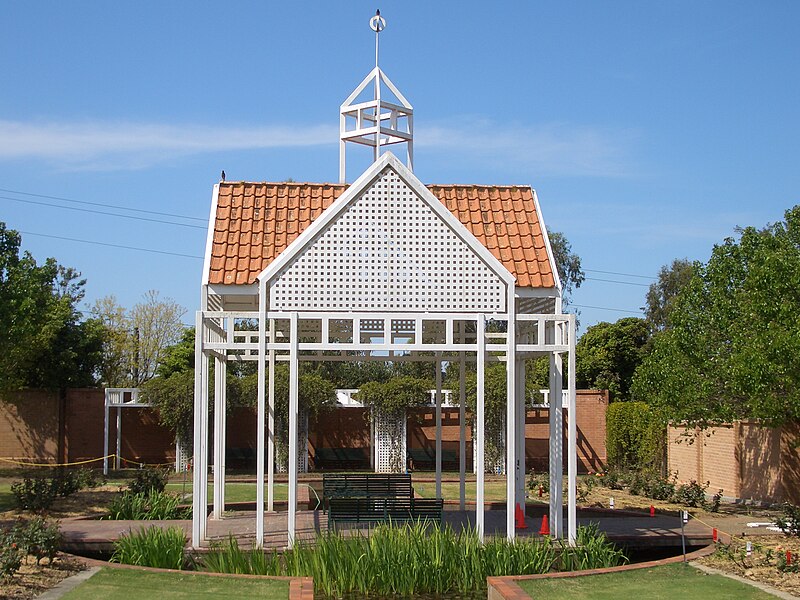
328, 497, 444, 529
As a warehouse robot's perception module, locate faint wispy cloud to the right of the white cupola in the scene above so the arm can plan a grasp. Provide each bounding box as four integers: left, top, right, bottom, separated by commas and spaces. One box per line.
417, 119, 639, 177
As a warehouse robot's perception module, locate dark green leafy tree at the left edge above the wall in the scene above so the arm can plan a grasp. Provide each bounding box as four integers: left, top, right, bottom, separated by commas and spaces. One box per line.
0, 222, 101, 394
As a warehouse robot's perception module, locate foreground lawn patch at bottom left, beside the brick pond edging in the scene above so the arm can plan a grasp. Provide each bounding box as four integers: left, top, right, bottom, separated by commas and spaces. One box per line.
62, 569, 289, 600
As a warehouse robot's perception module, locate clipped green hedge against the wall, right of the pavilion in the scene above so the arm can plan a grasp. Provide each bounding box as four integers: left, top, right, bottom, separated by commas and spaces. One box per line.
606, 402, 666, 471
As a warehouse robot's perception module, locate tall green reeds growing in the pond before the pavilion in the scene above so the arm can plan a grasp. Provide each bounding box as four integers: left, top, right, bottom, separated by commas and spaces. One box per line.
201, 523, 625, 597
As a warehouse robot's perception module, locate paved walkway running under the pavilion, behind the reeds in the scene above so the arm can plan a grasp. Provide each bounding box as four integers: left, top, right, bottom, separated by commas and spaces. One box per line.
61, 510, 711, 552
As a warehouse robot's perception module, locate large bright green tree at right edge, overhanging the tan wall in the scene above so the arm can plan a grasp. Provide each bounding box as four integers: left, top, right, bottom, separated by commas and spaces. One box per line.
633, 206, 800, 426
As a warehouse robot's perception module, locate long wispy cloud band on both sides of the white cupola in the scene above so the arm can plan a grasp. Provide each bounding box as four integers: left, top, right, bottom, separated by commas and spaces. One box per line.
0, 118, 636, 177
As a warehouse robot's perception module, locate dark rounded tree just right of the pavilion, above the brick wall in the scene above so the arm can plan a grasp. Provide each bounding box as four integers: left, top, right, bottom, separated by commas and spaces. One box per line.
575, 317, 650, 401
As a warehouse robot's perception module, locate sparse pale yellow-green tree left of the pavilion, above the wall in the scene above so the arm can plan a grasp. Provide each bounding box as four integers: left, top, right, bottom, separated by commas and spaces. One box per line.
93, 290, 186, 387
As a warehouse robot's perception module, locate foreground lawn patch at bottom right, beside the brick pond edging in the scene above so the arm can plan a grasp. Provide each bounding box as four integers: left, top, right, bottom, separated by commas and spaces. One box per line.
517, 564, 774, 600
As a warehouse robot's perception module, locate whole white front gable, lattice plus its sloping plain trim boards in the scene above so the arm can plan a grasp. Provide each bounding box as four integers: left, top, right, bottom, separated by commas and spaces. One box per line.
259, 153, 515, 313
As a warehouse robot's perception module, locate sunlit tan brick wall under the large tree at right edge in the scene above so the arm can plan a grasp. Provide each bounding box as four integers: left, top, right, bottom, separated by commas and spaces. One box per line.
667, 421, 800, 502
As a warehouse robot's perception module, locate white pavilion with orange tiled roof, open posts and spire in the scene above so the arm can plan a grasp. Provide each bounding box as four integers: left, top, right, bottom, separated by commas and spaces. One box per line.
191, 15, 577, 548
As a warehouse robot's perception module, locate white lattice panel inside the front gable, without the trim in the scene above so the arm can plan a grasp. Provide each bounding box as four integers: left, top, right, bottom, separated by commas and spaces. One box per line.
270, 169, 505, 312
